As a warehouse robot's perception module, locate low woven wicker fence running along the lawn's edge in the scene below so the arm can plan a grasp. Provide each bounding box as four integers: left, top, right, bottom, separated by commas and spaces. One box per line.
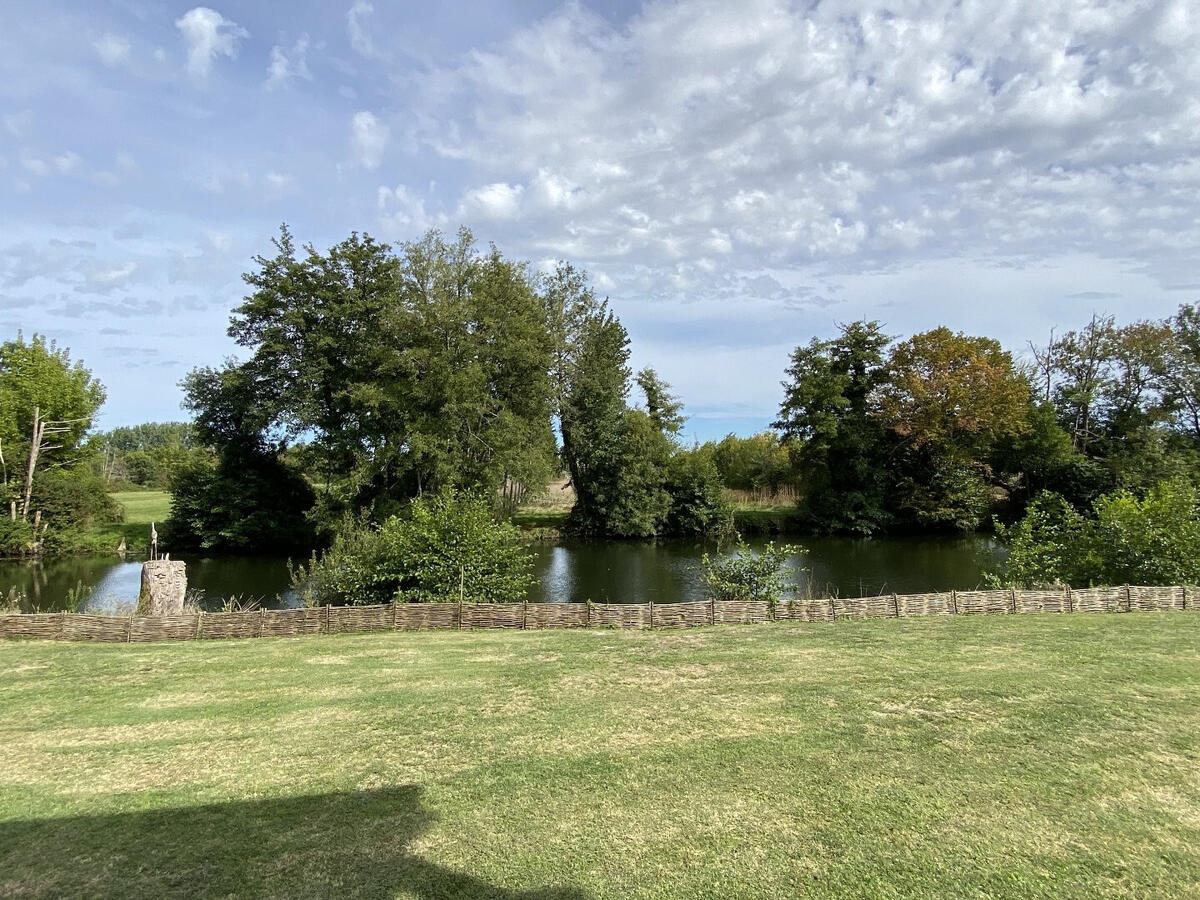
0, 586, 1200, 643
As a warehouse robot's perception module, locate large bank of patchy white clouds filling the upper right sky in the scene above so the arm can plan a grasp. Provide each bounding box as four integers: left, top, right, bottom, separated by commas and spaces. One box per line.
414, 0, 1200, 298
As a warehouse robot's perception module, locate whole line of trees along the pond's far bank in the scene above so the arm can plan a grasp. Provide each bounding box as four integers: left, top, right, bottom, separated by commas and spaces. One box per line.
0, 227, 1200, 592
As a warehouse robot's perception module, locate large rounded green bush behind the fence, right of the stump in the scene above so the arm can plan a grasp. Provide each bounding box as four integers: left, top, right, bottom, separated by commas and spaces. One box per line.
293, 488, 533, 606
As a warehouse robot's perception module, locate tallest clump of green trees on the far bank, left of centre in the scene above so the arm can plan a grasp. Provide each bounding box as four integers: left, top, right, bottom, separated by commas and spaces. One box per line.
172, 228, 728, 546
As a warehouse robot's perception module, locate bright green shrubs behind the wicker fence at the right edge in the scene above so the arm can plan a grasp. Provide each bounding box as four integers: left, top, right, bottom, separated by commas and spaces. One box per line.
995, 479, 1200, 587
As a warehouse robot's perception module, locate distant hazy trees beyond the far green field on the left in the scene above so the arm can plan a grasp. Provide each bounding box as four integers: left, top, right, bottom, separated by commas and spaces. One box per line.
89, 422, 209, 491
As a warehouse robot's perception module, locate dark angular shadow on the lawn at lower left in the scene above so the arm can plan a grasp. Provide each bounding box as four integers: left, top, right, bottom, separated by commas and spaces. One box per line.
0, 786, 586, 900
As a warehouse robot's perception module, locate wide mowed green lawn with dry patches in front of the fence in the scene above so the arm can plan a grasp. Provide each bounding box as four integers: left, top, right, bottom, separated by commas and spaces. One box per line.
0, 612, 1200, 900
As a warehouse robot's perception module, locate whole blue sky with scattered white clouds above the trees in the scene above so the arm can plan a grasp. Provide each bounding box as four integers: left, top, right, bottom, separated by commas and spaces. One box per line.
0, 0, 1200, 440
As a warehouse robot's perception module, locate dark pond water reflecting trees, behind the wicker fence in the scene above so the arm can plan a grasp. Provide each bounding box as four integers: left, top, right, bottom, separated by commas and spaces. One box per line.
0, 535, 1004, 612
